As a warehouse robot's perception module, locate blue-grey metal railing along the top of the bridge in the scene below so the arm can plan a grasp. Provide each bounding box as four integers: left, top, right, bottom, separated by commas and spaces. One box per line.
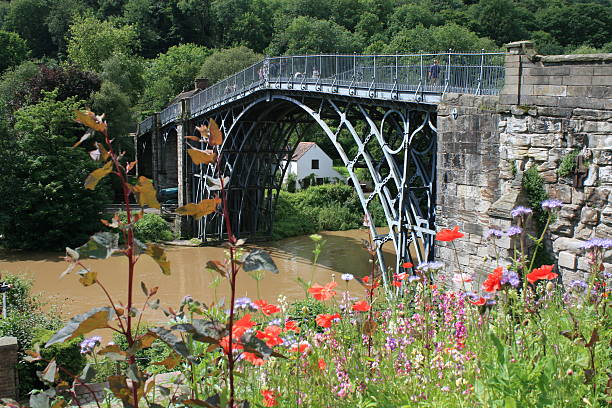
141, 50, 505, 133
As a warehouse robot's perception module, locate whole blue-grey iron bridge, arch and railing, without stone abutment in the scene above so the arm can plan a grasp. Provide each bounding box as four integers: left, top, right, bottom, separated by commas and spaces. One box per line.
138, 51, 504, 282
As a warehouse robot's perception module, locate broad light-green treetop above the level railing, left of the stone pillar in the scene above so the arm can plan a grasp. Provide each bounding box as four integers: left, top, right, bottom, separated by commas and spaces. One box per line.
385, 23, 497, 53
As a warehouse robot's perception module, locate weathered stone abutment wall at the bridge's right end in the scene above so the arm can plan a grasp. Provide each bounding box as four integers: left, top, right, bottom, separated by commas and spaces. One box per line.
438, 42, 612, 282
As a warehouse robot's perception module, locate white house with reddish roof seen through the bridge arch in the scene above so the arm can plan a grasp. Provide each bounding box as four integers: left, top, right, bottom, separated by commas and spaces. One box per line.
283, 142, 344, 190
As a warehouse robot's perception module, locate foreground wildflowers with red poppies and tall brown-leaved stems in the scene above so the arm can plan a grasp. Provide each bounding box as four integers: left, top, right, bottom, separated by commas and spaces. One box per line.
15, 112, 612, 408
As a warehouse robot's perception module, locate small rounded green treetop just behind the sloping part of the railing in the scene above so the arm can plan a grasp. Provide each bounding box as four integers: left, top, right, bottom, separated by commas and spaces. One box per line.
199, 46, 263, 84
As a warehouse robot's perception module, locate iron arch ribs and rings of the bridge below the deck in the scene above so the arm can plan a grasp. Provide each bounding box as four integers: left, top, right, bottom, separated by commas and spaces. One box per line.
191, 91, 436, 280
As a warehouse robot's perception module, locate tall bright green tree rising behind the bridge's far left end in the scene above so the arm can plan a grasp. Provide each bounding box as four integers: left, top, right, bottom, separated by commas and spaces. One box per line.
141, 44, 210, 113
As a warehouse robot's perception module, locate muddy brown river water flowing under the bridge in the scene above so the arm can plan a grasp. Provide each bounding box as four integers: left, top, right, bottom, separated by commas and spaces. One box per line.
0, 230, 395, 332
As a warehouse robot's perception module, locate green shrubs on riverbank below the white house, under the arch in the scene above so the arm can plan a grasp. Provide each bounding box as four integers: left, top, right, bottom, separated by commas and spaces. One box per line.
272, 184, 384, 239
